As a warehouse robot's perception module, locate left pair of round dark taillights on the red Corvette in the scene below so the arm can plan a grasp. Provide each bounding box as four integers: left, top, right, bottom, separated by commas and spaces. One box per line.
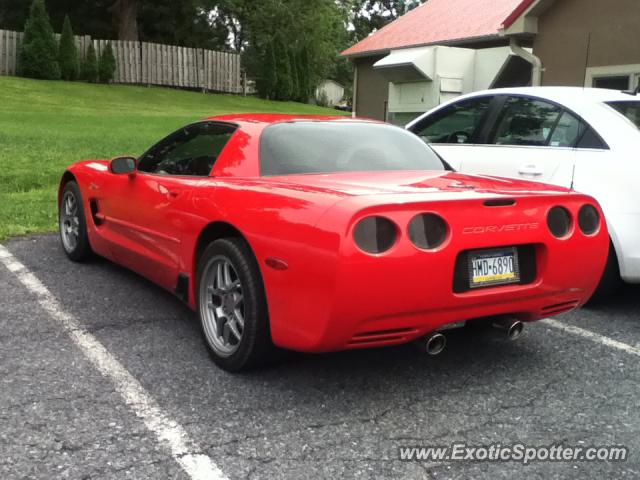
353, 213, 449, 255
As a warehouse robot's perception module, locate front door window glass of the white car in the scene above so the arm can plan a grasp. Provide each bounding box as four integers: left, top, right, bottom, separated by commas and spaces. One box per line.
412, 97, 493, 144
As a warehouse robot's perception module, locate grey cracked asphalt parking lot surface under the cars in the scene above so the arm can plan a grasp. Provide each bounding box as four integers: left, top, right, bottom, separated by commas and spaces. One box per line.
0, 235, 640, 479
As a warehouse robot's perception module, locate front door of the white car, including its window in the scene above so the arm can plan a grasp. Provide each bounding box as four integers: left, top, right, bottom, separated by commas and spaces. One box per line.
409, 95, 494, 171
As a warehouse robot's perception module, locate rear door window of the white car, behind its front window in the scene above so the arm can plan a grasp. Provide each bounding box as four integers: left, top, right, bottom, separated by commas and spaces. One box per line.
491, 97, 562, 147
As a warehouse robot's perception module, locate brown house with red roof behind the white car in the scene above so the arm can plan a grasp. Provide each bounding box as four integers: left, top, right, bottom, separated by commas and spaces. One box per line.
343, 0, 640, 124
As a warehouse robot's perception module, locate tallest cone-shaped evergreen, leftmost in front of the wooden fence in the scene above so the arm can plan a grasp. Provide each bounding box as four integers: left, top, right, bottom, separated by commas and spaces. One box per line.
20, 0, 60, 80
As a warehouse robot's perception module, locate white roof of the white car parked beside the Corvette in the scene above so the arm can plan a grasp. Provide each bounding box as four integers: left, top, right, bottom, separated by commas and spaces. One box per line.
462, 87, 640, 104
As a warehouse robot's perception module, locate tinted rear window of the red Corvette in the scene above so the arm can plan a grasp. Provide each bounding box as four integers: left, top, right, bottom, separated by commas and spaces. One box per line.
260, 121, 445, 176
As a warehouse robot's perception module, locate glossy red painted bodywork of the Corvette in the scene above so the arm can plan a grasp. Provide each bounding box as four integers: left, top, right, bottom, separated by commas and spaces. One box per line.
63, 115, 609, 352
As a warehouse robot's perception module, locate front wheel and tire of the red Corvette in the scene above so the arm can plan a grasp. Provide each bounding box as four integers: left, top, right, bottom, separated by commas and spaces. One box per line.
58, 181, 93, 262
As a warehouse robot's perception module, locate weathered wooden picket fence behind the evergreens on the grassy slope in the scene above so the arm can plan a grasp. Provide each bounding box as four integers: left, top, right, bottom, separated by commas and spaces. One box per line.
0, 30, 246, 93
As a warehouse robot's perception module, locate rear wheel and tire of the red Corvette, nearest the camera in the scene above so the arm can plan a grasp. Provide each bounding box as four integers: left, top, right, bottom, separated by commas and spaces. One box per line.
197, 238, 273, 372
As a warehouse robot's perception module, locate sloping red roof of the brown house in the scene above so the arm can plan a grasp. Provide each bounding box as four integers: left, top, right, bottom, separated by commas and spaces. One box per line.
342, 0, 534, 57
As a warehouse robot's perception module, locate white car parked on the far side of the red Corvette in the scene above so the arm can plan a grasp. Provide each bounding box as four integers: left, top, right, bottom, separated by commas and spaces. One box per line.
407, 87, 640, 296
